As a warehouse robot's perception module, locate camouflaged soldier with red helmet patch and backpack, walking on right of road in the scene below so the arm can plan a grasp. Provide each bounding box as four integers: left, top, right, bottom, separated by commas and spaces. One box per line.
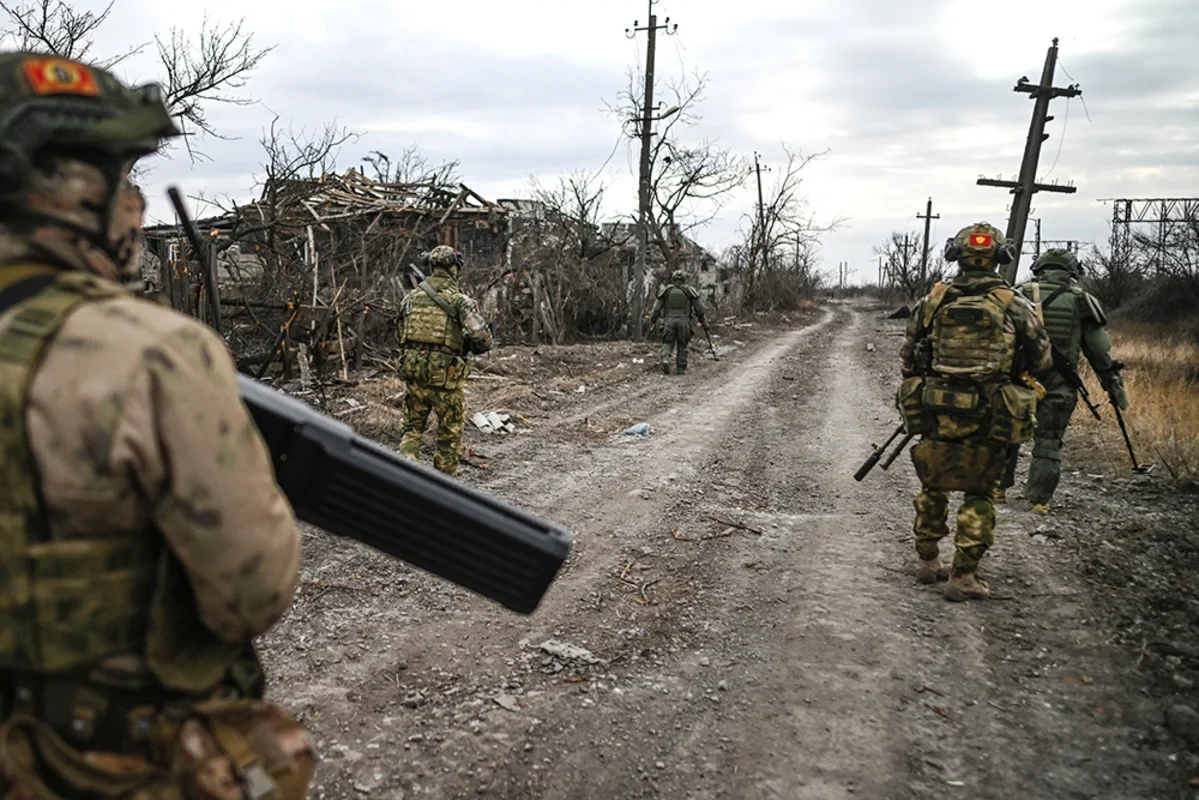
898, 222, 1052, 601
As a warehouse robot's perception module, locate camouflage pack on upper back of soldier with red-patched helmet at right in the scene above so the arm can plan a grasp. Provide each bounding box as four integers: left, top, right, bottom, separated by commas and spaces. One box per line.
929, 284, 1016, 383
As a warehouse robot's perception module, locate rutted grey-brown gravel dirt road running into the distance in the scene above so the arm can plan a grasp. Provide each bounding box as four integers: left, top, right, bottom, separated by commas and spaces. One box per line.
257, 305, 1199, 800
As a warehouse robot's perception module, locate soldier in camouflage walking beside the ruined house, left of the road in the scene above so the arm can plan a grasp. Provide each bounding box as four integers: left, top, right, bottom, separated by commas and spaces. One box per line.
399, 245, 492, 475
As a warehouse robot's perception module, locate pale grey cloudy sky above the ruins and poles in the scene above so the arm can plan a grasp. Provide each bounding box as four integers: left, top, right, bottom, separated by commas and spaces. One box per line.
80, 0, 1199, 281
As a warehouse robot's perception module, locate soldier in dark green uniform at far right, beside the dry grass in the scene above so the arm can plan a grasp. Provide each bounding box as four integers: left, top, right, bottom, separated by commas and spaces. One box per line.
1012, 249, 1128, 513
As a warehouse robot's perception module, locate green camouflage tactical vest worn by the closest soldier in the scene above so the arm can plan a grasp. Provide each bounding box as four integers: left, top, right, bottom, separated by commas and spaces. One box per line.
0, 266, 248, 692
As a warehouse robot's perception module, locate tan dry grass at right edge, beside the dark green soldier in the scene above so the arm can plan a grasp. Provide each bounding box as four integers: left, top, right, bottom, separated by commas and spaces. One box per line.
1071, 324, 1199, 481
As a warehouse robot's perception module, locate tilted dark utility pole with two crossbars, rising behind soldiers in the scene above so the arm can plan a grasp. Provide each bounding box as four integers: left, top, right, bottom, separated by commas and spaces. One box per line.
978, 38, 1083, 283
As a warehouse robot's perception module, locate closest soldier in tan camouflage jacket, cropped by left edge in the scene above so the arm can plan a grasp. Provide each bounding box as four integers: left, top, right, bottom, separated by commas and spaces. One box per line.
0, 53, 315, 800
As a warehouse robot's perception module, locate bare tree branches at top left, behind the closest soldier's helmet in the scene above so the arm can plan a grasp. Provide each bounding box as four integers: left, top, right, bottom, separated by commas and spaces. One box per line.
0, 0, 273, 160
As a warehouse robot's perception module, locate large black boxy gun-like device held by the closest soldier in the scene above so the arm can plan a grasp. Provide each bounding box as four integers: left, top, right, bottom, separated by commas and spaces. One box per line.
168, 187, 572, 614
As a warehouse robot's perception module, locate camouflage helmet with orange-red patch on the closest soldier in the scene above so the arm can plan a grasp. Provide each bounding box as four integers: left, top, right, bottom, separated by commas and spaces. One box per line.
0, 53, 180, 204
